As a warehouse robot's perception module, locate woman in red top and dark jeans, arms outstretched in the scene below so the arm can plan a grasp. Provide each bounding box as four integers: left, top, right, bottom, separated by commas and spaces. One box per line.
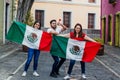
64, 23, 96, 80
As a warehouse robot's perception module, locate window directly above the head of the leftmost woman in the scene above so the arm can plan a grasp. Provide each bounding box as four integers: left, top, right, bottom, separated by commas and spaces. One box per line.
35, 10, 44, 27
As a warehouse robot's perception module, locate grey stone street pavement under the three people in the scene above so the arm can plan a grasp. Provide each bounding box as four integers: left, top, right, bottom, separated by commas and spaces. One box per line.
0, 43, 120, 80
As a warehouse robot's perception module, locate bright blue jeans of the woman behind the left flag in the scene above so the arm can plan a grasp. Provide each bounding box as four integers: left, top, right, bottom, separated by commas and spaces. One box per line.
24, 48, 40, 71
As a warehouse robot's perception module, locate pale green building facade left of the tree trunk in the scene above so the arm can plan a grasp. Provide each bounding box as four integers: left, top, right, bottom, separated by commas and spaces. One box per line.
0, 0, 14, 44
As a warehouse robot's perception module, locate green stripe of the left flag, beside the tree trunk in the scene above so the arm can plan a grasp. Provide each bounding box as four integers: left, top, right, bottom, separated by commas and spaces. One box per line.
6, 21, 26, 44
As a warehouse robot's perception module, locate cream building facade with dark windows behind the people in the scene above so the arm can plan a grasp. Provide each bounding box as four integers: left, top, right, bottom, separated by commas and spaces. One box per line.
31, 0, 101, 29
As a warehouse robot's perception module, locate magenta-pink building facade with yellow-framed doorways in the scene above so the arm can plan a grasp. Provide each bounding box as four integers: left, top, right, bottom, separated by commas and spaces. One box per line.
101, 0, 120, 47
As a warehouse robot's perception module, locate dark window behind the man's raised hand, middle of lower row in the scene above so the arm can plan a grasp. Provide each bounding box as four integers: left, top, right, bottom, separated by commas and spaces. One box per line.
63, 12, 71, 27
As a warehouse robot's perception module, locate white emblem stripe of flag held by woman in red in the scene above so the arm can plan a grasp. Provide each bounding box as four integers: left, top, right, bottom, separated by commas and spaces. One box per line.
66, 39, 86, 61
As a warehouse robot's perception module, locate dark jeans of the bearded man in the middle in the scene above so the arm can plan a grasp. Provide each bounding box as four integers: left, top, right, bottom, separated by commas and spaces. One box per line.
51, 55, 66, 73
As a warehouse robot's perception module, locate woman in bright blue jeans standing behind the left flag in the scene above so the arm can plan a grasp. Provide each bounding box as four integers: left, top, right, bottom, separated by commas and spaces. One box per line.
22, 21, 40, 76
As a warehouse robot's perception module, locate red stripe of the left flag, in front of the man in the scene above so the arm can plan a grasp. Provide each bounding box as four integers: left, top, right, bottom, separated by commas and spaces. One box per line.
39, 32, 52, 51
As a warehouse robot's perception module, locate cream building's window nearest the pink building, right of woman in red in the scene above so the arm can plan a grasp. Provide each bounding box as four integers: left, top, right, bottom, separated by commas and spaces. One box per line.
88, 13, 95, 29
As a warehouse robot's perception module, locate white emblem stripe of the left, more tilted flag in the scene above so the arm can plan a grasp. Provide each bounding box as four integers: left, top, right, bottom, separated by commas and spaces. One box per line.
22, 26, 43, 49
